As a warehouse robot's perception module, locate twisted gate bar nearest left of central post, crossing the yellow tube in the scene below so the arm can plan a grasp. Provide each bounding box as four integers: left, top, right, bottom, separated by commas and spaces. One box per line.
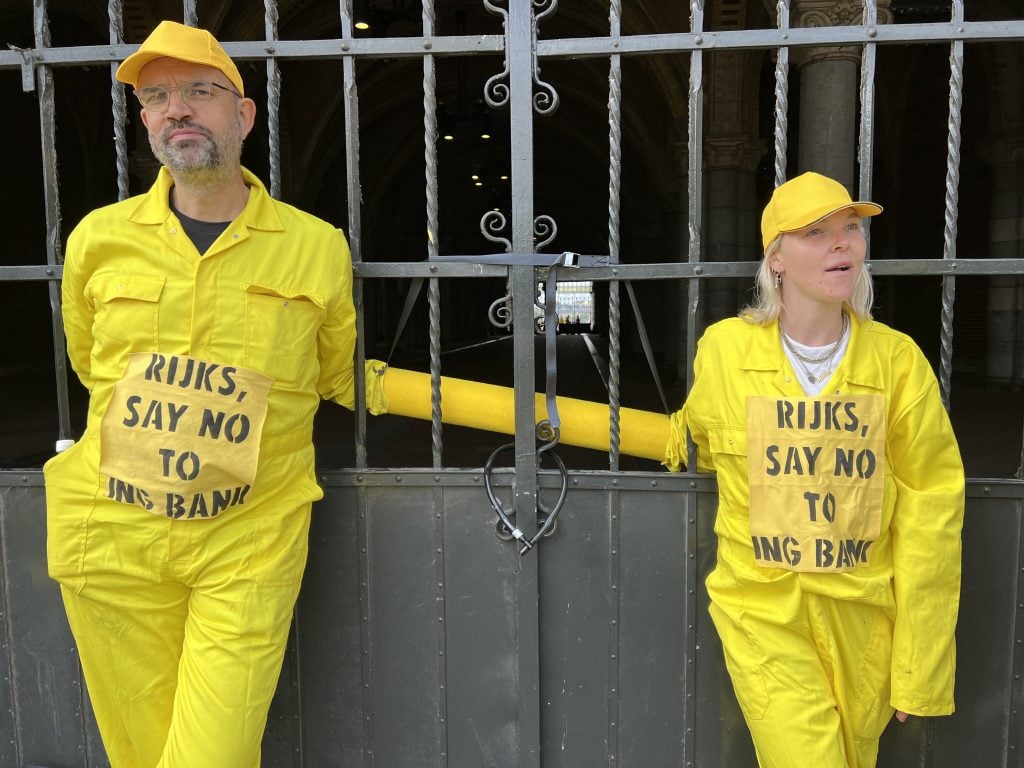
423, 0, 443, 469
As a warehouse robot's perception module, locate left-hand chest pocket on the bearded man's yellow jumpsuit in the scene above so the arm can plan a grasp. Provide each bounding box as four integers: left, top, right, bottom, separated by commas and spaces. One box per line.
85, 274, 166, 375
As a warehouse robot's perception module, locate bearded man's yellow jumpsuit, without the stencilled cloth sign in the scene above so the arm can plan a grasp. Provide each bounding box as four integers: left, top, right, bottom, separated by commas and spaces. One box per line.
44, 169, 355, 768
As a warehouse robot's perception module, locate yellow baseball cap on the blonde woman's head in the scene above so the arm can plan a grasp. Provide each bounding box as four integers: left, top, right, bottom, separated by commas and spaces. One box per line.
761, 171, 882, 250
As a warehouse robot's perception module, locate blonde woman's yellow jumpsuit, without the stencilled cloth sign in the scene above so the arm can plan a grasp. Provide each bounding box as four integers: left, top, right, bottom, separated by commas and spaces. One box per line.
665, 317, 964, 768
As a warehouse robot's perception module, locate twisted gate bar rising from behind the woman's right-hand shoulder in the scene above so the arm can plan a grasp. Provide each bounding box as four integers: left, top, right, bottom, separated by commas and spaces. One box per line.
939, 0, 964, 411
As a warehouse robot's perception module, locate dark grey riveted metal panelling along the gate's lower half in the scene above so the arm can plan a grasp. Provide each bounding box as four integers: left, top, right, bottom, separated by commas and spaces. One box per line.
0, 479, 1024, 768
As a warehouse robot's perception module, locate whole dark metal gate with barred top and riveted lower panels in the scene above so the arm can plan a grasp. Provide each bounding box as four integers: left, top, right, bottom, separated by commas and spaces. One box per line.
0, 0, 1024, 768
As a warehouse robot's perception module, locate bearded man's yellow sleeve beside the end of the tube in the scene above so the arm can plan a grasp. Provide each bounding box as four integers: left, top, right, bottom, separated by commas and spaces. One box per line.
316, 229, 355, 410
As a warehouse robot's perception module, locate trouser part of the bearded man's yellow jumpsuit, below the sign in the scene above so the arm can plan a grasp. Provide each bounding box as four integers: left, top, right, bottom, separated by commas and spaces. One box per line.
48, 475, 310, 768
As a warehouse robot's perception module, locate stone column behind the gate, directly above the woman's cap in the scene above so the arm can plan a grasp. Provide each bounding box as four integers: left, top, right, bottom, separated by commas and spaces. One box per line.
791, 0, 892, 189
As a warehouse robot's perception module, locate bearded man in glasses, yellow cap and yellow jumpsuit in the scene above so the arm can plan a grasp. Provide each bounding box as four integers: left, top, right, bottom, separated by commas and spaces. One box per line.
45, 22, 355, 768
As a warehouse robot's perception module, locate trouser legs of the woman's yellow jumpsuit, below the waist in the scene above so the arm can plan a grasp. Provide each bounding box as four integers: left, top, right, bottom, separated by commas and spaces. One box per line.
711, 594, 893, 768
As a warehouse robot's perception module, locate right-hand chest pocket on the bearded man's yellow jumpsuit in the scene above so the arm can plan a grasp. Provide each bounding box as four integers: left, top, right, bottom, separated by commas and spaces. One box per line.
245, 285, 325, 386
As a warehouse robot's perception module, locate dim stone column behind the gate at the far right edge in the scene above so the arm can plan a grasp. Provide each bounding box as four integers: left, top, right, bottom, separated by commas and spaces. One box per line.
985, 137, 1024, 384
